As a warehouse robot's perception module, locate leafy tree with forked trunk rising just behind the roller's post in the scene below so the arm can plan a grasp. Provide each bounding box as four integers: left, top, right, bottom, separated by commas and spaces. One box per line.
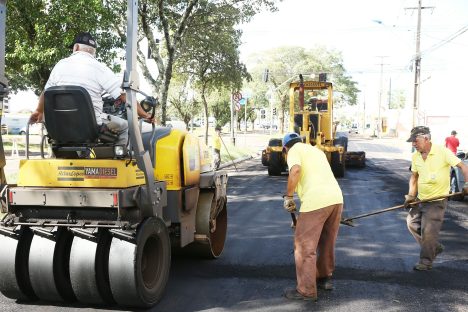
139, 0, 277, 124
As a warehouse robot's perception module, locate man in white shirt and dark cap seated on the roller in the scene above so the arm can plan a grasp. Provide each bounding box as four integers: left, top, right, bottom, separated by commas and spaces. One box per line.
29, 32, 154, 145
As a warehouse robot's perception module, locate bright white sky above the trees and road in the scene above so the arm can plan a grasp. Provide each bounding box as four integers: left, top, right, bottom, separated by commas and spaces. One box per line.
240, 0, 468, 140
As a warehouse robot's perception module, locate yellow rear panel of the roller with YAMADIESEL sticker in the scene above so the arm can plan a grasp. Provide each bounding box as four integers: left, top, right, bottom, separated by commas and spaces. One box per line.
18, 159, 145, 188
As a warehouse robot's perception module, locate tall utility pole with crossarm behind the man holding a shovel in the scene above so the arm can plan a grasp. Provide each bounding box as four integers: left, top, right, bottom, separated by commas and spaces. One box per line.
405, 0, 434, 127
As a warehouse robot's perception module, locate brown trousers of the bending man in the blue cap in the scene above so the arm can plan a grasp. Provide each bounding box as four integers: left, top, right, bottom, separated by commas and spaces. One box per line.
294, 204, 343, 296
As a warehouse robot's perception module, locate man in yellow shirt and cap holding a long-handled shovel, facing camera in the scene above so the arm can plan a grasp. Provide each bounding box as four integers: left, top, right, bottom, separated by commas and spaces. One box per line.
405, 126, 468, 271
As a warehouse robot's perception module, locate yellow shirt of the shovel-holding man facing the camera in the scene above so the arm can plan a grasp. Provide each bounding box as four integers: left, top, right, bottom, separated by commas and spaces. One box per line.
411, 144, 460, 200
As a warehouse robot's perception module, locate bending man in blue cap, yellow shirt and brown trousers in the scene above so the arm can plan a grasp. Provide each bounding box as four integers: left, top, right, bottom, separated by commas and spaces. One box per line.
283, 133, 343, 301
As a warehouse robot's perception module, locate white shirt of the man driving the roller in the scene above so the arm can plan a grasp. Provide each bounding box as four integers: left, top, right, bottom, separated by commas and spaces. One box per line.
44, 51, 122, 124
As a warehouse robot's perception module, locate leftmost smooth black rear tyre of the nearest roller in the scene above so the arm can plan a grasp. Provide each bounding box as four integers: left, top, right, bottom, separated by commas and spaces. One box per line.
0, 228, 37, 300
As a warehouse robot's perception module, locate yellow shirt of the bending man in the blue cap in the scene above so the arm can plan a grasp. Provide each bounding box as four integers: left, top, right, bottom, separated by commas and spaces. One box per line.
287, 143, 343, 212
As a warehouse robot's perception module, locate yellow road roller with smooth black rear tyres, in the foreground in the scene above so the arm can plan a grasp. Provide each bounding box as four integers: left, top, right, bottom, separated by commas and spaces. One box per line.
0, 0, 227, 308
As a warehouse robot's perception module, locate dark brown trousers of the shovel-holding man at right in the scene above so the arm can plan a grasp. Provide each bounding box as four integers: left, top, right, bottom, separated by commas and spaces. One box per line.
406, 199, 447, 265
